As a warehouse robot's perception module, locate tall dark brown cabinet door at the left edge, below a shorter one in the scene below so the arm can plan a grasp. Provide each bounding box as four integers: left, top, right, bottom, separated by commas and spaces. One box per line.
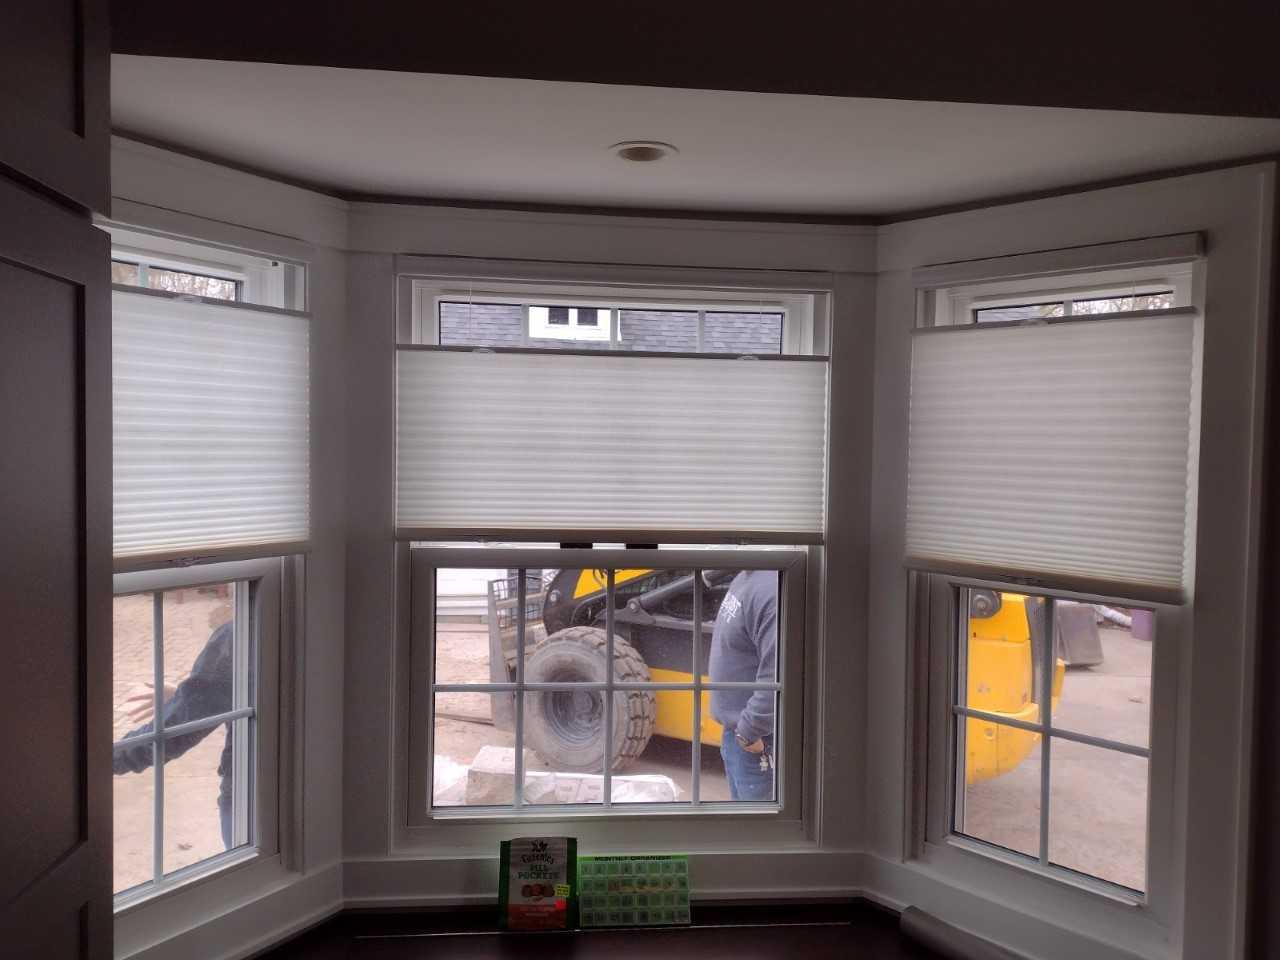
0, 178, 111, 960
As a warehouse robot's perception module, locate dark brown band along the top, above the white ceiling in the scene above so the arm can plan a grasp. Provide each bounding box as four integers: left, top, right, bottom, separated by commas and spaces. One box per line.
111, 0, 1280, 116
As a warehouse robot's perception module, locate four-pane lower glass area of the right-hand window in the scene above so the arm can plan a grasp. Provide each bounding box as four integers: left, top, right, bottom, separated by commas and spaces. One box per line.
948, 586, 1155, 895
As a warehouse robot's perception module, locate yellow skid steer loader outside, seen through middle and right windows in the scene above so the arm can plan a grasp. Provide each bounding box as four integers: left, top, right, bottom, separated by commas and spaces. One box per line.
488, 570, 1062, 783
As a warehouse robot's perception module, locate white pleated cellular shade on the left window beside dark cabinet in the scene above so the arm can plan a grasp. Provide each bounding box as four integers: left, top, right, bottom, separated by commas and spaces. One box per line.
111, 291, 310, 558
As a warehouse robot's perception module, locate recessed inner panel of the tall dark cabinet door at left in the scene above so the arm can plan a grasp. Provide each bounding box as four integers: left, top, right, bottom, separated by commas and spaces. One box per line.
0, 261, 84, 902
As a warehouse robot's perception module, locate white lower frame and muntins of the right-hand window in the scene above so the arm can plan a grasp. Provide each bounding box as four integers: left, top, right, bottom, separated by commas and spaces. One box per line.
908, 573, 1190, 918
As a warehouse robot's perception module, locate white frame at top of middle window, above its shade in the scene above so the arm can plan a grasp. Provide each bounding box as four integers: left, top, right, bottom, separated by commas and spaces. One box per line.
410, 278, 827, 355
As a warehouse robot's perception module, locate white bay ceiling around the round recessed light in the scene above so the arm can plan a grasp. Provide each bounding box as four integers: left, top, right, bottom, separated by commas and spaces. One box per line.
111, 55, 1280, 215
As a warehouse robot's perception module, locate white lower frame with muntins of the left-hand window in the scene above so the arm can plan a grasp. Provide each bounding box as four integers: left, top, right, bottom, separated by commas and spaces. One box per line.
113, 558, 294, 915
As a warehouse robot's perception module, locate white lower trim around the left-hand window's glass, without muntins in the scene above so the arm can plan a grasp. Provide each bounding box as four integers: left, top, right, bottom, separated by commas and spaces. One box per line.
113, 559, 293, 915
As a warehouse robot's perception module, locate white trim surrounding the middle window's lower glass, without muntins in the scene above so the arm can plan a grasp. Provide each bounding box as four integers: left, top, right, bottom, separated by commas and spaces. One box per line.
393, 543, 820, 855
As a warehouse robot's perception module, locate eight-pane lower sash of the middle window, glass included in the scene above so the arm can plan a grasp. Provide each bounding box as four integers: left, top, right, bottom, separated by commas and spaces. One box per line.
411, 547, 806, 818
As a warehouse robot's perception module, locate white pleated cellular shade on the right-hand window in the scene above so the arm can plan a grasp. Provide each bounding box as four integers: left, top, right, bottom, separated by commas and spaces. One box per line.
906, 310, 1196, 599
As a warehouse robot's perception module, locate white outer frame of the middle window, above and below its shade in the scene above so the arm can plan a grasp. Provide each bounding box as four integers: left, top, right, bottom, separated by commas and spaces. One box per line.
389, 263, 833, 856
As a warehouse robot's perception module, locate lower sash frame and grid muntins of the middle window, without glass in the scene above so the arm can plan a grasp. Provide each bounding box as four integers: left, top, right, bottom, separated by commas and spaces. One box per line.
404, 547, 809, 827
